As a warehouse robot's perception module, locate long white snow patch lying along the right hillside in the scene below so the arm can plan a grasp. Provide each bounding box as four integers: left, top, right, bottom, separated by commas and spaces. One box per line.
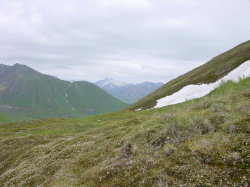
154, 60, 250, 108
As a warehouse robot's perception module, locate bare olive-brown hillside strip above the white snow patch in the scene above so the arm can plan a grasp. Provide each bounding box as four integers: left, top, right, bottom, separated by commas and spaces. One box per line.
128, 41, 250, 110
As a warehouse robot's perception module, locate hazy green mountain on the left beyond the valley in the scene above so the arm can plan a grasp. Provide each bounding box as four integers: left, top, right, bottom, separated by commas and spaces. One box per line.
0, 64, 126, 122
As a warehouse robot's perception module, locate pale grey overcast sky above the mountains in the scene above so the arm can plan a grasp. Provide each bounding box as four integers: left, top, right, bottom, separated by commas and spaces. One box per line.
0, 0, 250, 82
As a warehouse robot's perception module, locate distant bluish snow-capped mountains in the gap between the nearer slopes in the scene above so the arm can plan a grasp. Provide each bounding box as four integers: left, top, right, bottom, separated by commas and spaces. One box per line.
95, 78, 163, 104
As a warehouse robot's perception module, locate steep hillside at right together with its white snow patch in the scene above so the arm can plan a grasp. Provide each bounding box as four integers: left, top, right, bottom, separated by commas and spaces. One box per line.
128, 41, 250, 111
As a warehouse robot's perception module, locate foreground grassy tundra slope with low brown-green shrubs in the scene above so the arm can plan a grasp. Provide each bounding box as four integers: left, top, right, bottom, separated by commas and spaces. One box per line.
0, 78, 250, 187
